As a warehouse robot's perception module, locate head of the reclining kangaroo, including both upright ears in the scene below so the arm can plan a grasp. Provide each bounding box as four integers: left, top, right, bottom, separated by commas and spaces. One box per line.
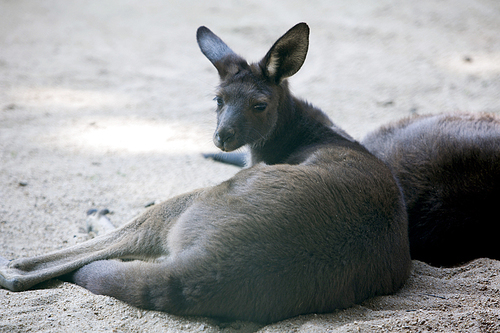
197, 23, 309, 151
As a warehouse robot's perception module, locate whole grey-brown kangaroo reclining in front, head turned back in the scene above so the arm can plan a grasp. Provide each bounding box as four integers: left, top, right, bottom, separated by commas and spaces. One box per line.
0, 23, 411, 323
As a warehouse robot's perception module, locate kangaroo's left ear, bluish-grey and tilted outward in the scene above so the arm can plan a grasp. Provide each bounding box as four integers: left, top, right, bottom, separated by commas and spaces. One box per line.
196, 27, 248, 79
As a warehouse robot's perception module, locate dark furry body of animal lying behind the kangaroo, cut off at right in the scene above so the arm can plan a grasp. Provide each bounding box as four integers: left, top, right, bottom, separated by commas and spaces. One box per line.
363, 114, 500, 265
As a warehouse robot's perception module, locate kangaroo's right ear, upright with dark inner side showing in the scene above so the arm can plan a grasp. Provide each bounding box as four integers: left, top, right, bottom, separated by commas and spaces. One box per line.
259, 23, 309, 83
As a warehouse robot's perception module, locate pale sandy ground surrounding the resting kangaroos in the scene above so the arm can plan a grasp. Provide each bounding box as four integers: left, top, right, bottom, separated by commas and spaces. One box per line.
0, 0, 500, 332
